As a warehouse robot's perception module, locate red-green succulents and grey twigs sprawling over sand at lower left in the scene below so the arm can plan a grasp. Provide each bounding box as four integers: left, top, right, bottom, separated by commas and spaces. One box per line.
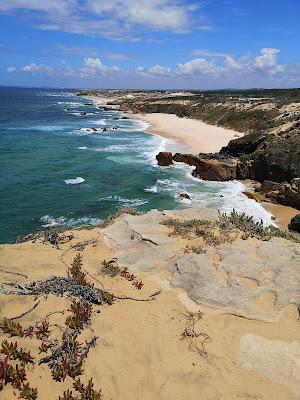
0, 253, 160, 400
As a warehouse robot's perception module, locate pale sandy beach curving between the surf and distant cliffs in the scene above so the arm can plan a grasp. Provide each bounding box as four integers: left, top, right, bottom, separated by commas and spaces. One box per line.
131, 113, 244, 154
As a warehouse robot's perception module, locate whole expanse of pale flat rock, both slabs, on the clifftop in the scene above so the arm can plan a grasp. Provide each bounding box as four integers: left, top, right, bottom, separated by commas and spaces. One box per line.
104, 208, 300, 321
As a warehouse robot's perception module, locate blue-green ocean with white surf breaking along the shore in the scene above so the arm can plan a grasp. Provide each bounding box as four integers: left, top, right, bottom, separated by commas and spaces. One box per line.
0, 87, 271, 243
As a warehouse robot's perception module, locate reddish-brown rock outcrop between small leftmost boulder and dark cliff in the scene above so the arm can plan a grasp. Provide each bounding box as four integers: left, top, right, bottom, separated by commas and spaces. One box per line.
173, 153, 237, 181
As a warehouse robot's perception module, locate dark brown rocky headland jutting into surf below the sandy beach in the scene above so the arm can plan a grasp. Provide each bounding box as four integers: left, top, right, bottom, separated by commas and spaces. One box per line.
157, 122, 300, 210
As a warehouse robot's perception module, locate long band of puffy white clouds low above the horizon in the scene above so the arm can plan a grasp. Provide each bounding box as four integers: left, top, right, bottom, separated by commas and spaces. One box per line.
6, 48, 300, 87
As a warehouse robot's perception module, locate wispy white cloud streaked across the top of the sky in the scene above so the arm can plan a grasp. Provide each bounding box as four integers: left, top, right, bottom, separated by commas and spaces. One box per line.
0, 0, 207, 40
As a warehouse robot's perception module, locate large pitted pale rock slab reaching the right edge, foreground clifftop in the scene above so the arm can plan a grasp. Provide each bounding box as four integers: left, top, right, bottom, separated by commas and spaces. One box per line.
169, 239, 300, 321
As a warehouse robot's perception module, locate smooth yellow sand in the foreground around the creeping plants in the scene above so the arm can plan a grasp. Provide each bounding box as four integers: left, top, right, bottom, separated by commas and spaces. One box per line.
0, 228, 300, 400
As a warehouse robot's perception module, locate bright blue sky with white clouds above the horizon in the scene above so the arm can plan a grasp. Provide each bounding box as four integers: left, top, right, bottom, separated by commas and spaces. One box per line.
0, 0, 300, 90
